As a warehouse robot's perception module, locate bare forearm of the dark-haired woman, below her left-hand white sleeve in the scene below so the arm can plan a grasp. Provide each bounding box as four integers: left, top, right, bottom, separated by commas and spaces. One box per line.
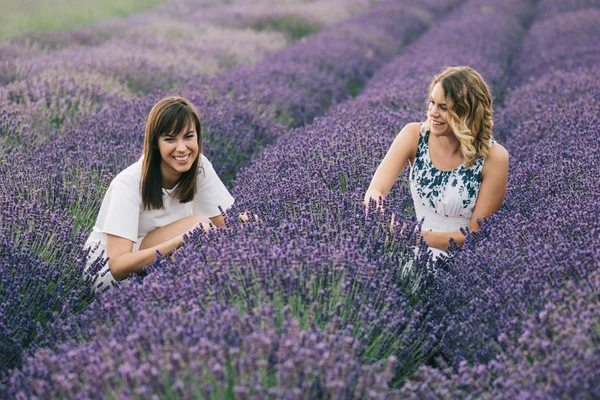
108, 237, 183, 281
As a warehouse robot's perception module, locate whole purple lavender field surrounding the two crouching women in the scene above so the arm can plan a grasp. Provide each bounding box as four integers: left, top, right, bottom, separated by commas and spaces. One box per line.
0, 0, 600, 399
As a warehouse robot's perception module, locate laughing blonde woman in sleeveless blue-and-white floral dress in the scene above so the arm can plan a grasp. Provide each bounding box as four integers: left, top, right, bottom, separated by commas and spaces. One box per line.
365, 67, 508, 257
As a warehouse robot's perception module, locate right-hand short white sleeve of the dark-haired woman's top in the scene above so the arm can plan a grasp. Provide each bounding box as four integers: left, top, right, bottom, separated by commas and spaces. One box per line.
193, 154, 234, 218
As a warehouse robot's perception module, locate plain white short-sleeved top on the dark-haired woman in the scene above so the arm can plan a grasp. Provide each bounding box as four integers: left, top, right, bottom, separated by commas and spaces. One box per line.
85, 154, 234, 282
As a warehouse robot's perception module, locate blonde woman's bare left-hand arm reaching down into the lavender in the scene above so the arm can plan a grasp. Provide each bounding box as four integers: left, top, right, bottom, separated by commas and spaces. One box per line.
364, 122, 419, 205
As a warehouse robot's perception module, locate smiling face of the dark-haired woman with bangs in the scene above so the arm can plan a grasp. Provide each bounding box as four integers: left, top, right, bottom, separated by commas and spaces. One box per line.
158, 124, 198, 189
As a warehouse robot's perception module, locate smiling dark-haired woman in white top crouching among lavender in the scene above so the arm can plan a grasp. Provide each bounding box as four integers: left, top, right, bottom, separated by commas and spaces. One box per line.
86, 97, 234, 290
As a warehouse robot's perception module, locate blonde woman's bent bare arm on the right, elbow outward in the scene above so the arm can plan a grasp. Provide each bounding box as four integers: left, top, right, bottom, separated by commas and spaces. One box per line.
421, 144, 508, 250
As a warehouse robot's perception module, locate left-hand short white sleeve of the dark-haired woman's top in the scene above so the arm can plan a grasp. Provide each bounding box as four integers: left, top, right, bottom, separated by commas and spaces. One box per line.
100, 174, 141, 242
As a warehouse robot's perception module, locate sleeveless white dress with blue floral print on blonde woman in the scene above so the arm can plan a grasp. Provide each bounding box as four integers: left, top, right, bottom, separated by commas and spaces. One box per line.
410, 124, 494, 257
